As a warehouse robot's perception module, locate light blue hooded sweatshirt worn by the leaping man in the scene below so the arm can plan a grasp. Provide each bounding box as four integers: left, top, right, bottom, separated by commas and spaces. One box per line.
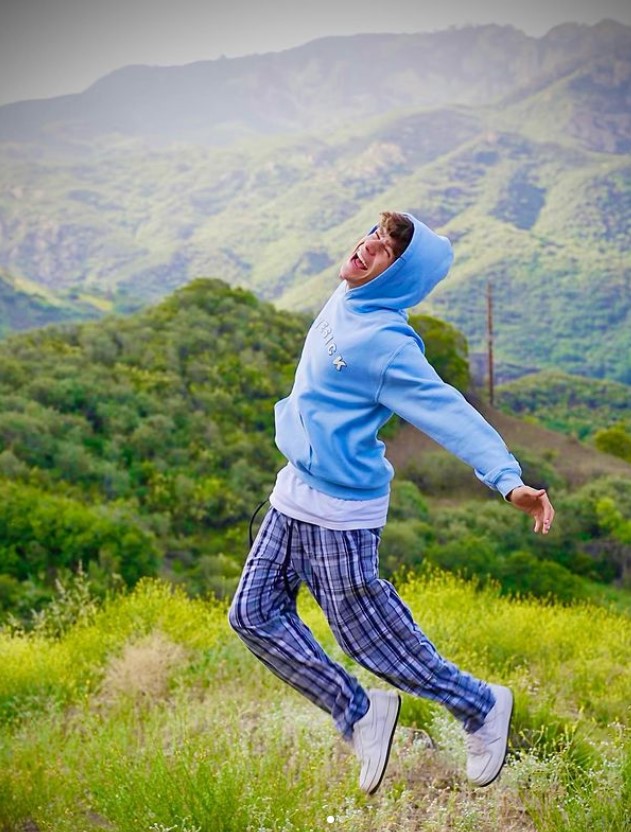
275, 214, 523, 500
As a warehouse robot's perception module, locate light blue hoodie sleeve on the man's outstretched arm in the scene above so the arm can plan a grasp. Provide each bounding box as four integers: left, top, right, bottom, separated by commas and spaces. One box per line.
378, 342, 523, 497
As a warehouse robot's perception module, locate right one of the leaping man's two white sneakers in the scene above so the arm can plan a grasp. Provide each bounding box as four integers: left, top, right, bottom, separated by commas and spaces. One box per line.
466, 685, 513, 786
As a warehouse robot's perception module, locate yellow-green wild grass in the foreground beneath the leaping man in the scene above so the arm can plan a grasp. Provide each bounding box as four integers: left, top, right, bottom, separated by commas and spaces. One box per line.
0, 575, 631, 832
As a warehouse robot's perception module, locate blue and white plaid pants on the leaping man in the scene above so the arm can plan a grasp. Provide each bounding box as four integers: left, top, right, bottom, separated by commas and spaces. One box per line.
229, 508, 494, 739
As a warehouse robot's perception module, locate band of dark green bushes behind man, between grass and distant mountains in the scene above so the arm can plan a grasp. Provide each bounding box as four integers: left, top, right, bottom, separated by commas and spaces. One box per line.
0, 280, 631, 617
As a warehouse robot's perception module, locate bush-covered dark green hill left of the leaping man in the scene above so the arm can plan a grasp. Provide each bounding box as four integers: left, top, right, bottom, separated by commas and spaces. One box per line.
0, 281, 306, 612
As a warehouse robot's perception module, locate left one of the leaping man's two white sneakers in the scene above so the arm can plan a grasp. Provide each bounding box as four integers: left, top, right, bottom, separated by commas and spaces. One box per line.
351, 690, 401, 794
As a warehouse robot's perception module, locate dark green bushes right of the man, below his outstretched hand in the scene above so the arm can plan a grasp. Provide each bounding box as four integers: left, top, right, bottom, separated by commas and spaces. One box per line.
380, 472, 631, 609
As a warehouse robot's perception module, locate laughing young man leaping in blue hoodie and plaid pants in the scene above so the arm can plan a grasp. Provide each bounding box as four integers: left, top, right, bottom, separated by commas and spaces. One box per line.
229, 212, 554, 794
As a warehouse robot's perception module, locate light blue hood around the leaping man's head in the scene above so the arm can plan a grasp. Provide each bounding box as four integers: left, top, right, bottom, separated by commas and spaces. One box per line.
346, 213, 453, 310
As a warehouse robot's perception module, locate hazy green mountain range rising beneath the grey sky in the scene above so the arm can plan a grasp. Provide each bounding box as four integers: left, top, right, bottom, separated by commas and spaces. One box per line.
0, 21, 631, 384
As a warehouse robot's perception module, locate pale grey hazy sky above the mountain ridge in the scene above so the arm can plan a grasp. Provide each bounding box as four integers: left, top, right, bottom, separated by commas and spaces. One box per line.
0, 0, 631, 104
